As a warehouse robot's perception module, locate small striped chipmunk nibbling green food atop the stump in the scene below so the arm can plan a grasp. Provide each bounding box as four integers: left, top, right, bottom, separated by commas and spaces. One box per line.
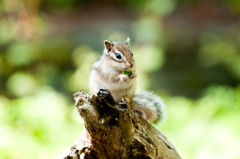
89, 38, 165, 122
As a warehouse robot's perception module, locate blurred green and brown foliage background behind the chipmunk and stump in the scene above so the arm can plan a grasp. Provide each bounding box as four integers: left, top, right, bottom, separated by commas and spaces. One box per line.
0, 0, 240, 159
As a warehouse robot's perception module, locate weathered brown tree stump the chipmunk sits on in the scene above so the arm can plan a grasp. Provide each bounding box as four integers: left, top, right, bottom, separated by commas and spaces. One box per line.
58, 89, 180, 159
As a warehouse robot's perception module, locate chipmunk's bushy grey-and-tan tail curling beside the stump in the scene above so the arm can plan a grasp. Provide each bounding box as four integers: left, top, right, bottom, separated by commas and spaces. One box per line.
133, 91, 166, 123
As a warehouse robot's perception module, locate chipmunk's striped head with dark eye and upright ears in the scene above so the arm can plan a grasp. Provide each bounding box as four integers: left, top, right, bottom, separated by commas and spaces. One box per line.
104, 38, 135, 71
